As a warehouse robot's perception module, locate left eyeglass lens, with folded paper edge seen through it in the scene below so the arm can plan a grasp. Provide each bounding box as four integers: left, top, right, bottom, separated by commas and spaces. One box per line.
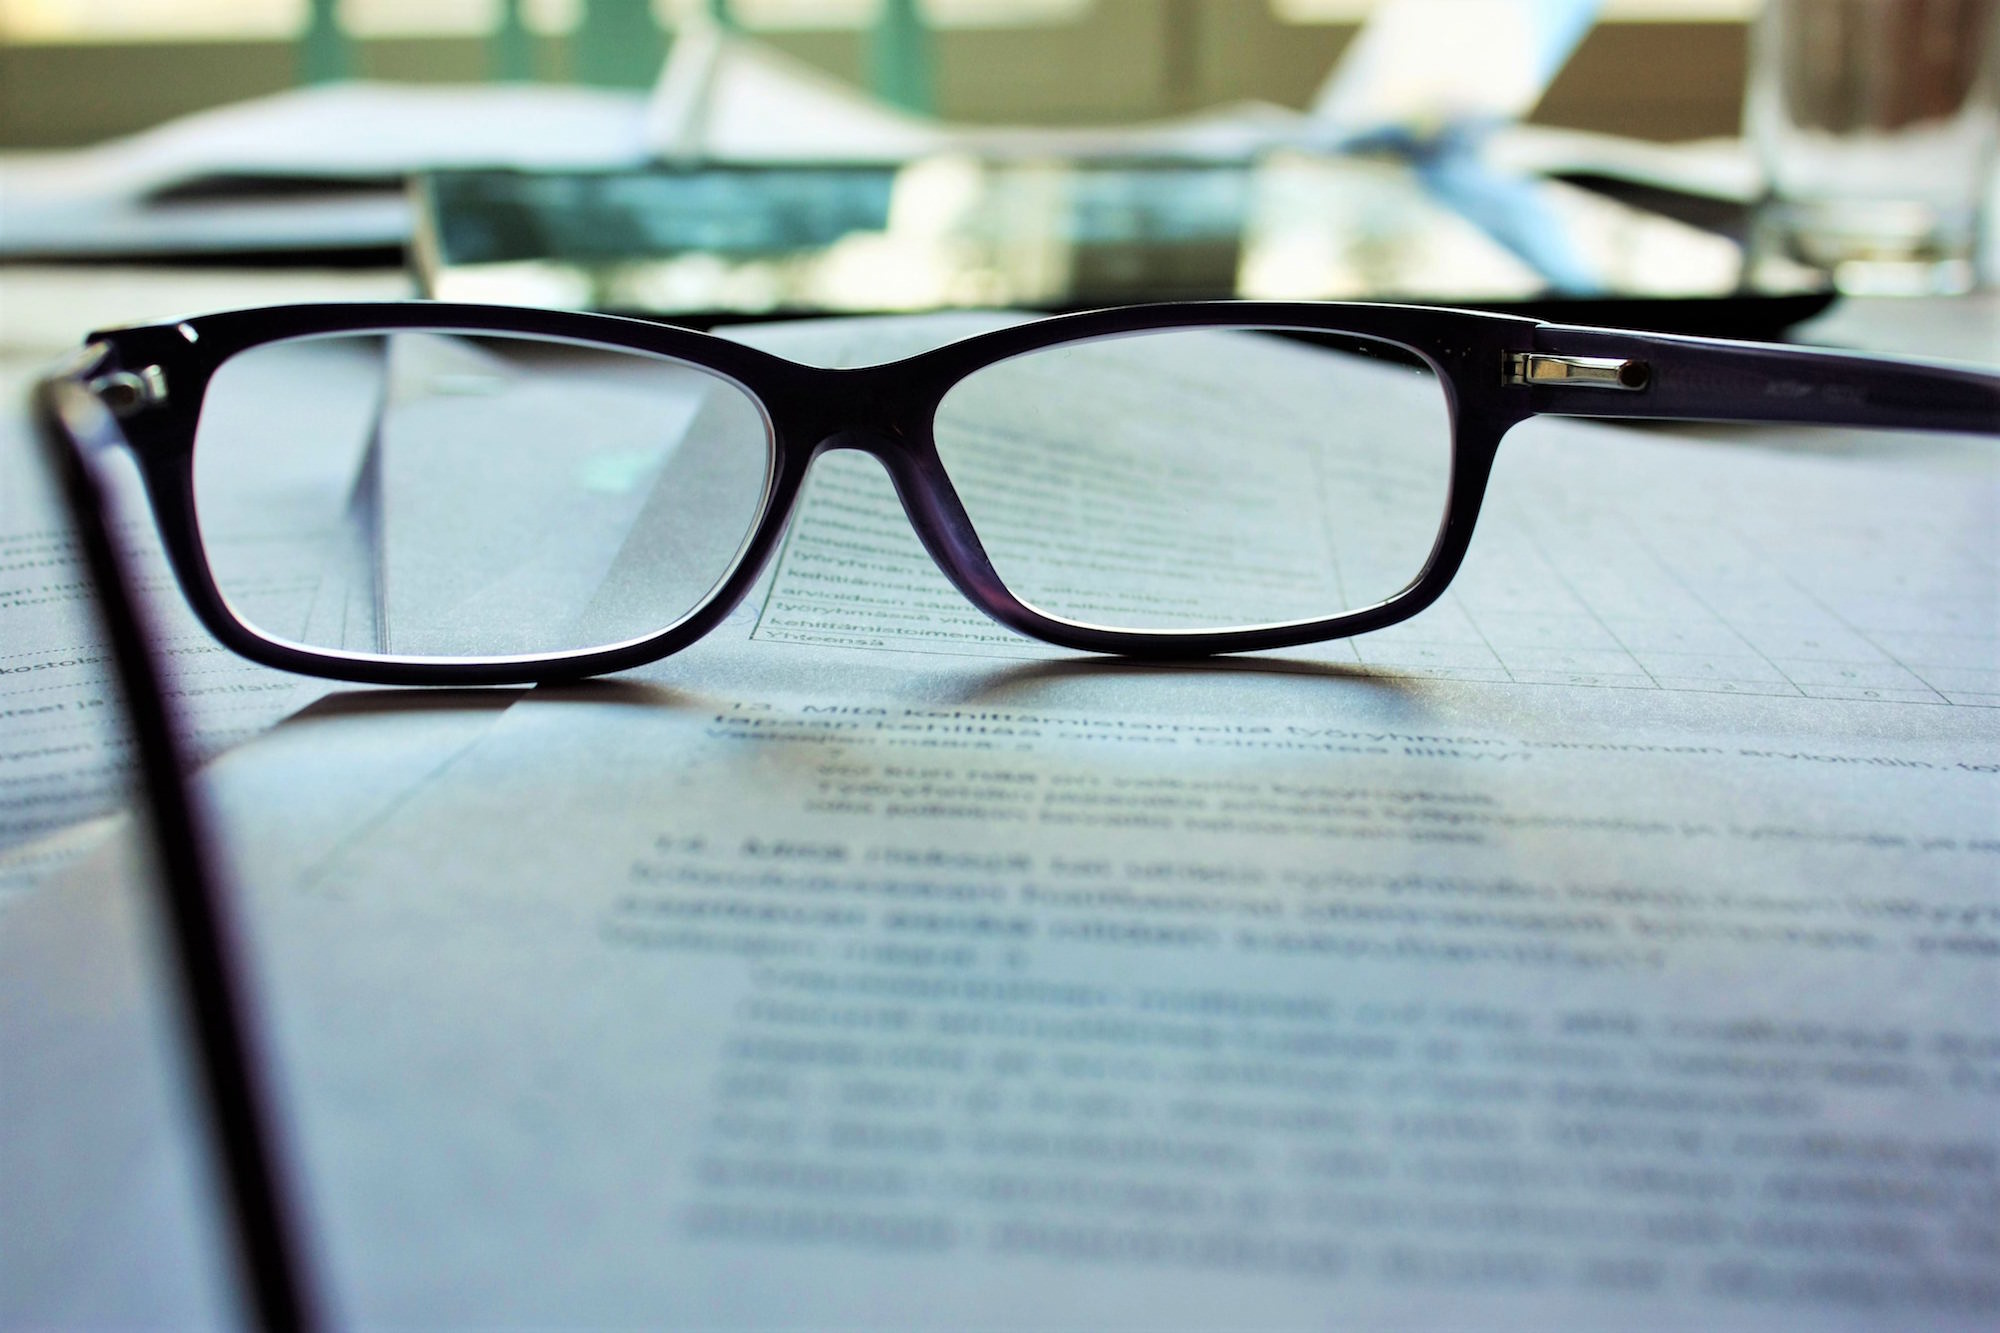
194, 332, 772, 658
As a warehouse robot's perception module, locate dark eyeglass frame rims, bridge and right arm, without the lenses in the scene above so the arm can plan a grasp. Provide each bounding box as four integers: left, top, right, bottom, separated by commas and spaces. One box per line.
47, 302, 2000, 685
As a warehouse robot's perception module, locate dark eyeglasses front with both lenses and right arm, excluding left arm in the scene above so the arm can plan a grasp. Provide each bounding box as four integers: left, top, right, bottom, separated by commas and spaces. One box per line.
35, 302, 2000, 685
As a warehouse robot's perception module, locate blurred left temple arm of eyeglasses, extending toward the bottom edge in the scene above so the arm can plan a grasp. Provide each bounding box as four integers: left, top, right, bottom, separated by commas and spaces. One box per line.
30, 360, 320, 1329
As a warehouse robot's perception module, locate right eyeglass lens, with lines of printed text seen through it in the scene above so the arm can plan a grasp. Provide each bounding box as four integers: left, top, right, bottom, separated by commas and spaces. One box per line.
936, 328, 1452, 630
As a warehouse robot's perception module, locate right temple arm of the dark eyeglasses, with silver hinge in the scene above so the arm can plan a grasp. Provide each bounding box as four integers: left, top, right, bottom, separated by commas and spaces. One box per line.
1502, 324, 2000, 434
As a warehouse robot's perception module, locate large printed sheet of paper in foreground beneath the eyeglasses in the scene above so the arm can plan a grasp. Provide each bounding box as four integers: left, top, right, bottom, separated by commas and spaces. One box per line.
0, 306, 2000, 1329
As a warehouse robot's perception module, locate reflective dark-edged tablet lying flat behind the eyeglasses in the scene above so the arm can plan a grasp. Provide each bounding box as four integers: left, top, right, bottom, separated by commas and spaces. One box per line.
412, 154, 1832, 338
